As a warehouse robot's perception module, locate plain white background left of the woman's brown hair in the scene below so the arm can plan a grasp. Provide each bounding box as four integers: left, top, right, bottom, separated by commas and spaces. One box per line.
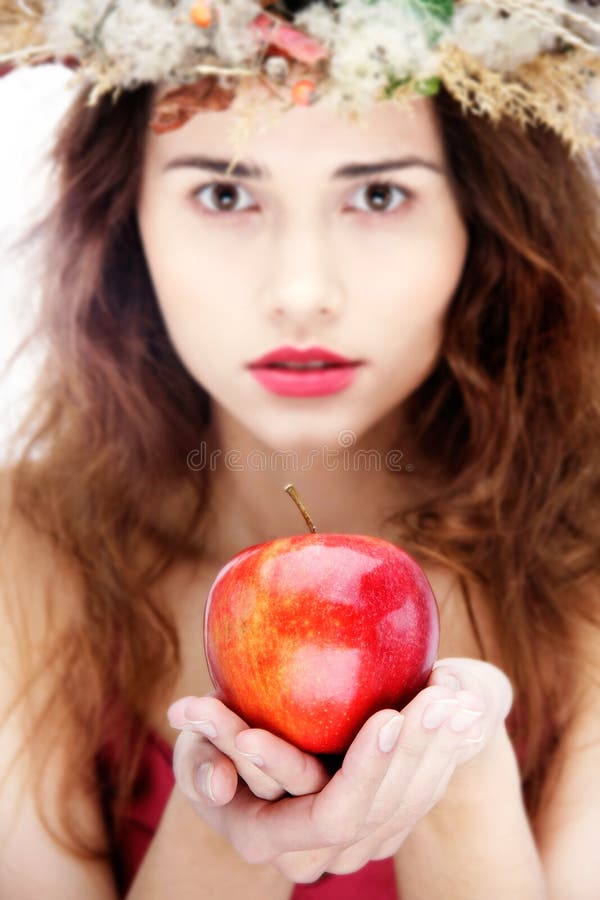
0, 65, 74, 464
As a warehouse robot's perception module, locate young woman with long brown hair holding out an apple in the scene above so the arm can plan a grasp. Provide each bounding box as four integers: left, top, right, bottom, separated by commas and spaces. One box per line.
0, 3, 600, 900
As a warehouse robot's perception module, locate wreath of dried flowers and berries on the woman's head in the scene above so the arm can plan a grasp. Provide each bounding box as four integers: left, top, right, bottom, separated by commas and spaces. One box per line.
0, 0, 600, 152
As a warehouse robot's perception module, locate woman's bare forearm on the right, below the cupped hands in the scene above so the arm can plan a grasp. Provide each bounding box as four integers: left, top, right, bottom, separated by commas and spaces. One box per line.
395, 727, 547, 900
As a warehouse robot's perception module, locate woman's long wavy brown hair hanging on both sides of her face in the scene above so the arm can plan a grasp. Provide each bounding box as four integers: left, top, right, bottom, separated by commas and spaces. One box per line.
1, 77, 600, 856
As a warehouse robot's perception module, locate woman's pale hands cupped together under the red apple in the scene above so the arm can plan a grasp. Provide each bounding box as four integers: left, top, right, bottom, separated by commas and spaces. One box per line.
169, 658, 512, 882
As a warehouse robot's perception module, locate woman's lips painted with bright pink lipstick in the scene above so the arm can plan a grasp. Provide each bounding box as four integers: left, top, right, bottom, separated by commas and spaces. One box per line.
249, 346, 363, 397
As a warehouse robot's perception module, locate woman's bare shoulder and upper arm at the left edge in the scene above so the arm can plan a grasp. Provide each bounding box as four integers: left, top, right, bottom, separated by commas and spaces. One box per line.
0, 469, 116, 900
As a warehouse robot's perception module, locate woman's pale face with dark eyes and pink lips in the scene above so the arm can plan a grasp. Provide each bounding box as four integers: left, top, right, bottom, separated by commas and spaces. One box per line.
138, 86, 467, 448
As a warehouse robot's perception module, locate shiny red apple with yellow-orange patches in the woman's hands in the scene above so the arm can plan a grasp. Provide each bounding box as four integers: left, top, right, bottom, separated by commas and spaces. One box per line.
204, 486, 439, 754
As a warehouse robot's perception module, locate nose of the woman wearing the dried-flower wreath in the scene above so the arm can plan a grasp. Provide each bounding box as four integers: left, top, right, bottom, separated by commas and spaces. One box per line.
263, 231, 344, 326
